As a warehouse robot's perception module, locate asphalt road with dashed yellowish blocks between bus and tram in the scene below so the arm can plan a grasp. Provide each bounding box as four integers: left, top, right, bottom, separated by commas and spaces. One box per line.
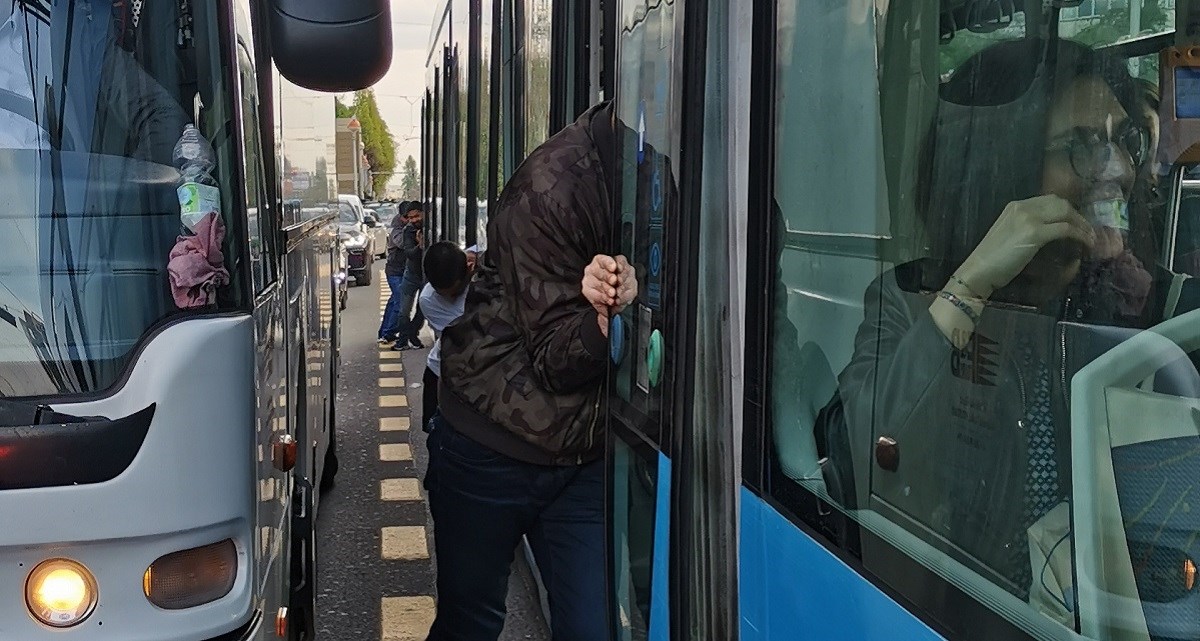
317, 262, 550, 641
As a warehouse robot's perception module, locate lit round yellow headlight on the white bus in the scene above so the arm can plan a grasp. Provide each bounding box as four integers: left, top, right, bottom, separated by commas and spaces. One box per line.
25, 558, 98, 628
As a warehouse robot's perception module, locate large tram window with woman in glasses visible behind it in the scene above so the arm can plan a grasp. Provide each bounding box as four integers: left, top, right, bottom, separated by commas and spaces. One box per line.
767, 0, 1200, 640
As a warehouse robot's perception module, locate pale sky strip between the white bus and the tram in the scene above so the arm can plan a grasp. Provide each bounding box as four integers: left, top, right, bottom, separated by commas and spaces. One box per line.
360, 0, 443, 195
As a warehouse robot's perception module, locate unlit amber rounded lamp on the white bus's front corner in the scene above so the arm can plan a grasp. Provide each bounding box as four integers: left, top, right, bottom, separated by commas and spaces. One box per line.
142, 539, 238, 610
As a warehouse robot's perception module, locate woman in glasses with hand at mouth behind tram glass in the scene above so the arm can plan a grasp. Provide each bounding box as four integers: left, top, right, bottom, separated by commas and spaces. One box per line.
839, 40, 1195, 609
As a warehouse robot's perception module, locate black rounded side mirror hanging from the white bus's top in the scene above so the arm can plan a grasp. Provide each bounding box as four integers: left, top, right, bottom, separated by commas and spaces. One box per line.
266, 0, 391, 92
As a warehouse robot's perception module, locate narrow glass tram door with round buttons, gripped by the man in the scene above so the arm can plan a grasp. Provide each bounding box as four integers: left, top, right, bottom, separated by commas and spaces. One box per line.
608, 0, 688, 641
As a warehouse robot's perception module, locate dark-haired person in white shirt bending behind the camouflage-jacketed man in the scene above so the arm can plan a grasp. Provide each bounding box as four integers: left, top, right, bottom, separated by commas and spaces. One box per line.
416, 240, 475, 431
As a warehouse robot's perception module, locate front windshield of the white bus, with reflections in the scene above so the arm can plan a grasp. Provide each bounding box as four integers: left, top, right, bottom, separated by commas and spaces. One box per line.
0, 0, 241, 397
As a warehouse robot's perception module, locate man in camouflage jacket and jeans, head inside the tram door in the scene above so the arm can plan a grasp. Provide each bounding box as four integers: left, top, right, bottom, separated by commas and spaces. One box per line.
426, 103, 637, 641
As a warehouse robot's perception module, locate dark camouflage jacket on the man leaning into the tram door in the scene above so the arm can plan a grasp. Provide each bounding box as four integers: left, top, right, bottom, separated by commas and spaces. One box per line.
440, 103, 616, 465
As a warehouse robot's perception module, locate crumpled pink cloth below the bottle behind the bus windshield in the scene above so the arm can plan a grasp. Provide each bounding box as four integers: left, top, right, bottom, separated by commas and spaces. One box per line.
167, 214, 229, 310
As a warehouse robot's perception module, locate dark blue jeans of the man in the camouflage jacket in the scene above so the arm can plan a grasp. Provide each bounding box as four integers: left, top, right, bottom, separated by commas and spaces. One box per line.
425, 414, 611, 641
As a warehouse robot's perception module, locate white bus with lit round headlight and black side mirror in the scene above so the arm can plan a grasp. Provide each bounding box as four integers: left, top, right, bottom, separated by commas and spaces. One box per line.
0, 0, 391, 641
